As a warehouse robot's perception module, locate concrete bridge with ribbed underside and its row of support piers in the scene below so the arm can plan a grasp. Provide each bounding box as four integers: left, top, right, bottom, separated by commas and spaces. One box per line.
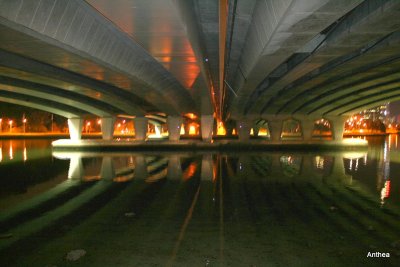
0, 0, 400, 141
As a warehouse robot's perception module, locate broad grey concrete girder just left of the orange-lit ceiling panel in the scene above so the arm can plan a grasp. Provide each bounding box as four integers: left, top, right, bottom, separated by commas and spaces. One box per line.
0, 0, 193, 114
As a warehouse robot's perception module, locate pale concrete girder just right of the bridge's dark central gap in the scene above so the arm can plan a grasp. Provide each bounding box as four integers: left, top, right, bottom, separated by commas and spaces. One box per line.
231, 1, 361, 116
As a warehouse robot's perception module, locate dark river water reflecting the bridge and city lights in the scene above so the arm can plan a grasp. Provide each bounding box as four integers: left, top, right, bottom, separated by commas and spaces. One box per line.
0, 135, 400, 266
